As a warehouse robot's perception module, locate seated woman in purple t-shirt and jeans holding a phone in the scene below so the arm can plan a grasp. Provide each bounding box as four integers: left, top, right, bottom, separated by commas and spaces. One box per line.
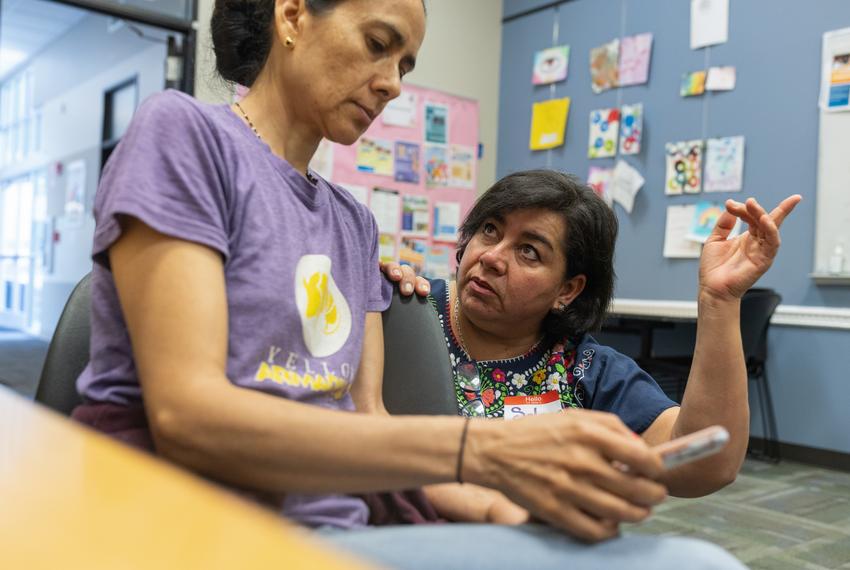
69, 0, 748, 568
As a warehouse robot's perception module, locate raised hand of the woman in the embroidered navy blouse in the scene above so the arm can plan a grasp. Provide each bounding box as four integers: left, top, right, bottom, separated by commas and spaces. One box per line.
699, 194, 802, 300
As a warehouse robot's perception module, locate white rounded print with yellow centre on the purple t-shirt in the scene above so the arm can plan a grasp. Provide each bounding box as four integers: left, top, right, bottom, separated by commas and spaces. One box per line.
295, 255, 351, 357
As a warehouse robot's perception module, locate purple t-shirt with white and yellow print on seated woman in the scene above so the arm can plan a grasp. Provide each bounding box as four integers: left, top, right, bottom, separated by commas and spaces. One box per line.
77, 91, 392, 527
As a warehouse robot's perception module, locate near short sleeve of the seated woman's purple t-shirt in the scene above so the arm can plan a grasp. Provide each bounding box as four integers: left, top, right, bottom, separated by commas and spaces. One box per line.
93, 91, 228, 265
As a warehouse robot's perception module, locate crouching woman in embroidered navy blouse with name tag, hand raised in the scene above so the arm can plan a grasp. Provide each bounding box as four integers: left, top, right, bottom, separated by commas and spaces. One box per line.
384, 170, 800, 521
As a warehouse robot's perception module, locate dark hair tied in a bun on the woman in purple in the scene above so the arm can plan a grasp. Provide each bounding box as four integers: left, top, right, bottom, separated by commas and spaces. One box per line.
210, 0, 425, 87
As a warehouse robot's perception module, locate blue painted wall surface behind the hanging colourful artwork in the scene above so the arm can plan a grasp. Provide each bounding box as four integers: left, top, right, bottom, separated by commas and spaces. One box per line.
496, 0, 850, 307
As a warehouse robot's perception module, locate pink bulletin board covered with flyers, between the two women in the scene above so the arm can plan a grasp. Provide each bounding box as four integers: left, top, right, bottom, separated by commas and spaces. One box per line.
318, 85, 479, 278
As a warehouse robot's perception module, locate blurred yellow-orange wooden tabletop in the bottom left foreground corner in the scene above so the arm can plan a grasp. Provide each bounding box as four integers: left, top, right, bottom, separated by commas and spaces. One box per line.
0, 386, 374, 570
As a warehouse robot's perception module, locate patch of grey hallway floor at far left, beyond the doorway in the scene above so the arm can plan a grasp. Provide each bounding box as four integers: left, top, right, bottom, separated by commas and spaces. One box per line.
0, 328, 48, 398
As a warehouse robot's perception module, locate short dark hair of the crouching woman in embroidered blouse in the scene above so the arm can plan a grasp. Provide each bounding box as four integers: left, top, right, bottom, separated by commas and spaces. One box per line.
457, 170, 618, 339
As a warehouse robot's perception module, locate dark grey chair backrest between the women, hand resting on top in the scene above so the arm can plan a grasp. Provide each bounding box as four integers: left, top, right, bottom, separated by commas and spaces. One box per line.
383, 287, 458, 415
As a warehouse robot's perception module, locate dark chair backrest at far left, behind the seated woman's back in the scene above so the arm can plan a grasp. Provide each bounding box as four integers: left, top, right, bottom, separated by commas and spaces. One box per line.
35, 273, 91, 415
